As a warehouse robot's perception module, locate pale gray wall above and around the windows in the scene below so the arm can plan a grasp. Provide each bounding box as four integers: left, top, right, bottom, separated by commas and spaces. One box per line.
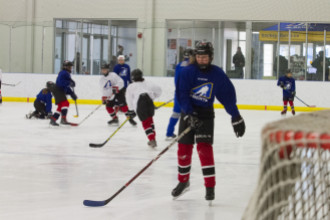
0, 0, 330, 75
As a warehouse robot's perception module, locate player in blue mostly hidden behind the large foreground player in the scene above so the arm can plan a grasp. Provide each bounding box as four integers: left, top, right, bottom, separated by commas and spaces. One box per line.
166, 48, 194, 140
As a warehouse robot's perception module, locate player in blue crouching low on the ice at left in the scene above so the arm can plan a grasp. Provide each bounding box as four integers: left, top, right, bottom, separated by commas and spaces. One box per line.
26, 81, 54, 119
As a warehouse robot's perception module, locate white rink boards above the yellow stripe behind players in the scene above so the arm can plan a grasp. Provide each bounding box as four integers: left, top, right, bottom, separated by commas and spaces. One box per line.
2, 73, 330, 107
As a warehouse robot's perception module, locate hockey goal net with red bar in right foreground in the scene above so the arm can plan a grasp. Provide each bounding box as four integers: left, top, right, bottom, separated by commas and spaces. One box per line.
243, 111, 330, 220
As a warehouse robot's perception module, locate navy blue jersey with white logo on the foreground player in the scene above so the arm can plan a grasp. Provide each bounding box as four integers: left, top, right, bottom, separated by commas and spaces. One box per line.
176, 64, 239, 117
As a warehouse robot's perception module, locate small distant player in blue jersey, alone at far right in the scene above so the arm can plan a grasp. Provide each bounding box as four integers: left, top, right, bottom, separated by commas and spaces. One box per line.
277, 69, 296, 115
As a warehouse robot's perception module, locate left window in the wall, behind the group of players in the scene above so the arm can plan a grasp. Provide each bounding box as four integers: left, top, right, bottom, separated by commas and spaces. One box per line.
54, 19, 137, 75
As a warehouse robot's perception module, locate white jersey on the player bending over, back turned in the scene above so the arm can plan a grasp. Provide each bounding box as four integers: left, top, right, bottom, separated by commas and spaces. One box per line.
126, 80, 162, 112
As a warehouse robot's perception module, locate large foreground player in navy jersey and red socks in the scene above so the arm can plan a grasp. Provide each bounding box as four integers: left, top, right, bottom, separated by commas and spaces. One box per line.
172, 42, 245, 203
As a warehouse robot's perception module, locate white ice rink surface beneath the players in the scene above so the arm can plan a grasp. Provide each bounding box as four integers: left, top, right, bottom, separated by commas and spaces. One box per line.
0, 103, 291, 220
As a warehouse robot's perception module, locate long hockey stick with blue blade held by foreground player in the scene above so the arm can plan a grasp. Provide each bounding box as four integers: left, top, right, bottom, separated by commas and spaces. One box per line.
84, 127, 191, 207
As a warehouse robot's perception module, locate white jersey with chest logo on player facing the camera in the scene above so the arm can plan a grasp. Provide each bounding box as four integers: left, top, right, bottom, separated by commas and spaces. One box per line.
100, 72, 124, 99
